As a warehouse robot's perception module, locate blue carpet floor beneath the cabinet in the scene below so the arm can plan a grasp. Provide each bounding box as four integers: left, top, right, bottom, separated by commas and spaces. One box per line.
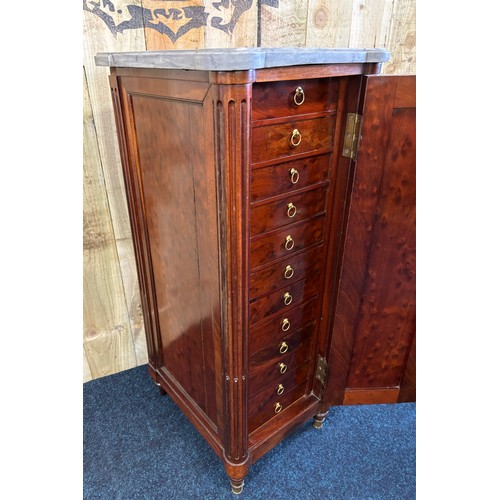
83, 366, 416, 500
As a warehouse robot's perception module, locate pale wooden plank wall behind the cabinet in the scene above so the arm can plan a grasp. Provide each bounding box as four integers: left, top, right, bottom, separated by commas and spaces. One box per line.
83, 0, 416, 381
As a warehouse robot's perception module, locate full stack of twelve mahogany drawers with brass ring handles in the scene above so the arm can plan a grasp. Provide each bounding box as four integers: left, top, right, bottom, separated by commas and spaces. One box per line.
248, 78, 338, 432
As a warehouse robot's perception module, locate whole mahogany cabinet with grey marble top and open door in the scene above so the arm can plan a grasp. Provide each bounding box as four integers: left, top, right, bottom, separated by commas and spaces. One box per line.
96, 49, 415, 493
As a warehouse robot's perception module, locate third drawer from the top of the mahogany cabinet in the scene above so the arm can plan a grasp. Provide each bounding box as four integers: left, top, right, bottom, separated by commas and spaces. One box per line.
250, 155, 330, 202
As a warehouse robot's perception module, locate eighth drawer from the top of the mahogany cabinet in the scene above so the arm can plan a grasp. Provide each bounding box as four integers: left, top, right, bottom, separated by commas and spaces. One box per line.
250, 299, 318, 354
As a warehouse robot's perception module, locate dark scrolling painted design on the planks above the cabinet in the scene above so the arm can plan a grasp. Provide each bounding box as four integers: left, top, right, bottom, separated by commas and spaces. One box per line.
83, 0, 279, 43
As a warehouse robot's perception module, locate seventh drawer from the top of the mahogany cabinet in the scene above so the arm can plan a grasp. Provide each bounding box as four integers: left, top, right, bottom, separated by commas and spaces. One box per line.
249, 274, 321, 323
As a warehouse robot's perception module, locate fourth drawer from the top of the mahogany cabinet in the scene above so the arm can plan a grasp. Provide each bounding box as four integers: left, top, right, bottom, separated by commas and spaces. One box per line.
250, 186, 328, 236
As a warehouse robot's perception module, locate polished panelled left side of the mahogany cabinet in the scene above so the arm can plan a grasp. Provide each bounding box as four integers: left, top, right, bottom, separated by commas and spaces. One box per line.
110, 68, 226, 458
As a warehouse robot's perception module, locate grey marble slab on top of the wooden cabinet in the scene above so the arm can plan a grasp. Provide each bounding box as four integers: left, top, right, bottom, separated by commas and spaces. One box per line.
95, 48, 389, 71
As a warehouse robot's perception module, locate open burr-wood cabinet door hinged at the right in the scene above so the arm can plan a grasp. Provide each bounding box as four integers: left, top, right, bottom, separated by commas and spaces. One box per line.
323, 75, 416, 406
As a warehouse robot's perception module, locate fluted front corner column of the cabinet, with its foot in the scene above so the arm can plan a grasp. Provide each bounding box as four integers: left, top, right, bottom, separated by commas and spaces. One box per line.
212, 72, 253, 484
